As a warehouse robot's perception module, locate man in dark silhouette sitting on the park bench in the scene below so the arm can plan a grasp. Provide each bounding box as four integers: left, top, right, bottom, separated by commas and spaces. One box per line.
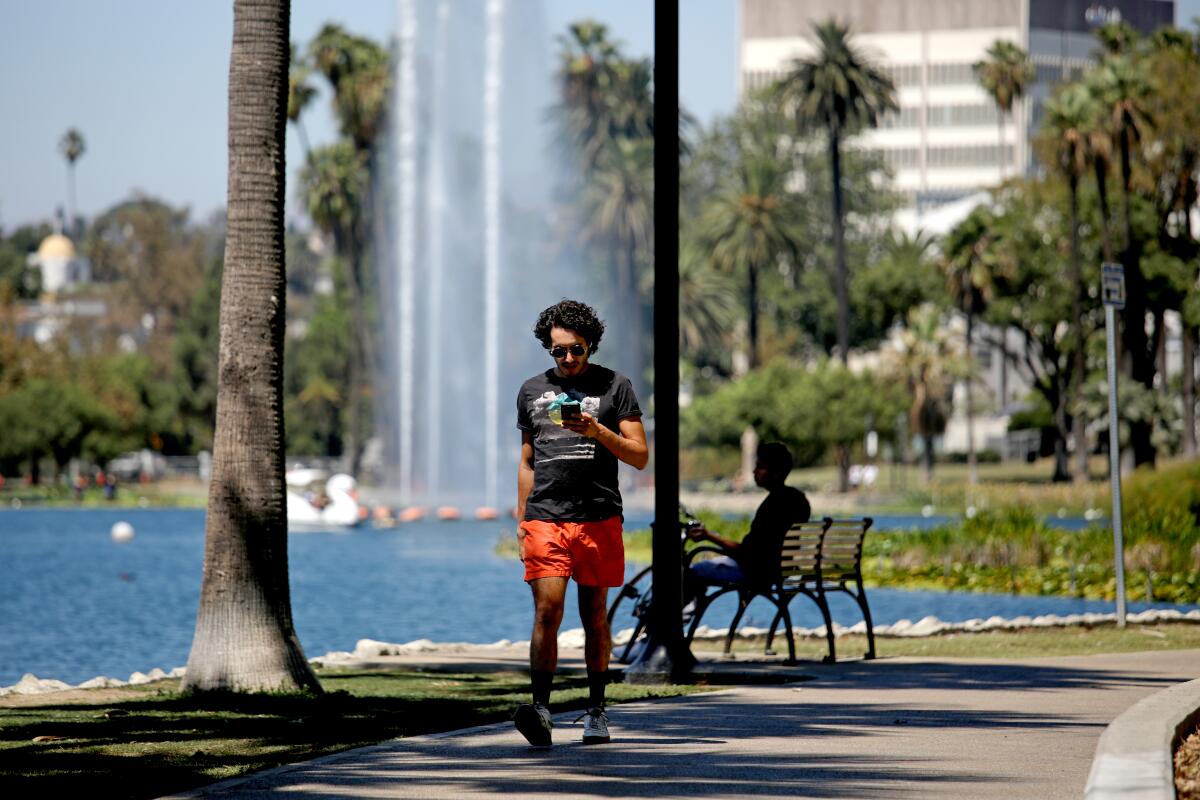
684, 441, 812, 610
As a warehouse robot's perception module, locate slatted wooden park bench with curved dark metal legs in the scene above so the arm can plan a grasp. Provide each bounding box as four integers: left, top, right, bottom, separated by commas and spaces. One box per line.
686, 517, 875, 663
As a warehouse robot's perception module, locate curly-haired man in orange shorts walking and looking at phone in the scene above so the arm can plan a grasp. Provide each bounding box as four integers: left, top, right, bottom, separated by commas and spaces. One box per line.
514, 300, 649, 747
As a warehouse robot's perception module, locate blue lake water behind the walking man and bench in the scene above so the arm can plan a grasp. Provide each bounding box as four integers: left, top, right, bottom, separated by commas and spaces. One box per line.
0, 509, 1182, 686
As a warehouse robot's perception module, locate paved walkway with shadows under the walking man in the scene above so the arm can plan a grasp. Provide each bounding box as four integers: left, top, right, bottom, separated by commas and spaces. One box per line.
175, 650, 1200, 800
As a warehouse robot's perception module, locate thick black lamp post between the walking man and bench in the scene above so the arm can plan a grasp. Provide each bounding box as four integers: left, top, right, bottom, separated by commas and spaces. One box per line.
625, 0, 695, 684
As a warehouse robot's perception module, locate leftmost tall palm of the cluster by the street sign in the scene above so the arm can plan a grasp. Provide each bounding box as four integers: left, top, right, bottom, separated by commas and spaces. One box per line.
1034, 83, 1097, 483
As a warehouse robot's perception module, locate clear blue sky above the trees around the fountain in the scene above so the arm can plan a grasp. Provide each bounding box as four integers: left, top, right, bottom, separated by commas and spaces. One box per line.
0, 0, 734, 230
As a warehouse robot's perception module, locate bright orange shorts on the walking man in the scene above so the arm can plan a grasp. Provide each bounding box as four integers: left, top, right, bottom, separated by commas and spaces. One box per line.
521, 517, 625, 587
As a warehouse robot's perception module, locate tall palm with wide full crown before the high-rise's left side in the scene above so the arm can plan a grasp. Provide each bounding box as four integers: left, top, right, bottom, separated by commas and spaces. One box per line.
776, 19, 899, 365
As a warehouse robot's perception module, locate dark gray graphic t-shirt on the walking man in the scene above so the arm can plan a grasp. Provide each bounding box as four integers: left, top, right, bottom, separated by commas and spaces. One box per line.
517, 363, 642, 522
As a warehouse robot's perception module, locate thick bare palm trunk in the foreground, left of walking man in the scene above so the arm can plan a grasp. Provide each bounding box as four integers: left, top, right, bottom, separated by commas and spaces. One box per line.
184, 0, 320, 692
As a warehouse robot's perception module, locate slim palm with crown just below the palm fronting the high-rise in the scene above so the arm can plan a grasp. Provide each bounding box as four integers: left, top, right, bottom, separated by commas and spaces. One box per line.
942, 207, 997, 485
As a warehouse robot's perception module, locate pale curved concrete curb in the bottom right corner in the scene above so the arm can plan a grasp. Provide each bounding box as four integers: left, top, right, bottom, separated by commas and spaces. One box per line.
1084, 680, 1200, 800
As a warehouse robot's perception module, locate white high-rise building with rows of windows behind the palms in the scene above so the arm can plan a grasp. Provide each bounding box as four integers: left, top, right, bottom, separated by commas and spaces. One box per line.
738, 0, 1175, 211
